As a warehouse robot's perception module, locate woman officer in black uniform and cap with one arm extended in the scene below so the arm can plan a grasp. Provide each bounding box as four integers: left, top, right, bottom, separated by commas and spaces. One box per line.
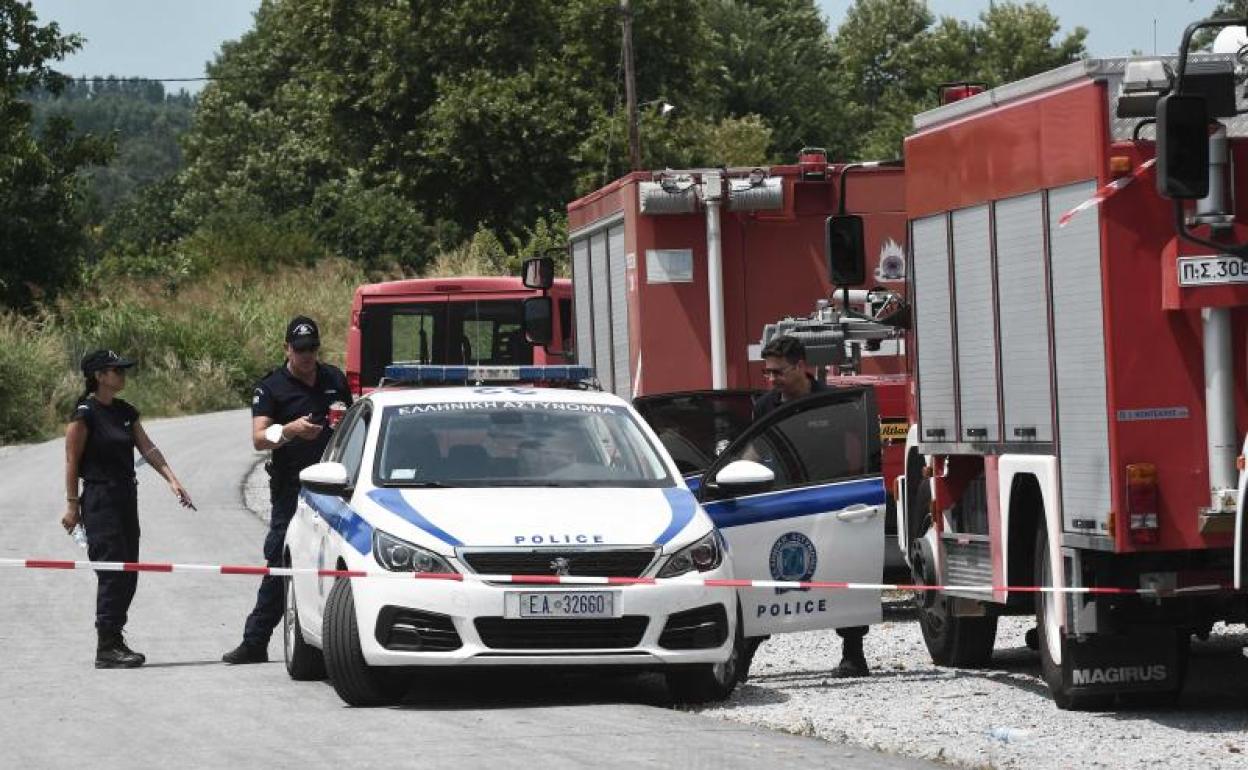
61, 351, 193, 669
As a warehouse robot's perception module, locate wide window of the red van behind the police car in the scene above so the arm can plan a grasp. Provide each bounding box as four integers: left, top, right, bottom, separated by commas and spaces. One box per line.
359, 298, 533, 388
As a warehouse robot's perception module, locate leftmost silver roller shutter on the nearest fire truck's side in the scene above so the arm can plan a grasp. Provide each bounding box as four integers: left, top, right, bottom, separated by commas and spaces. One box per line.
910, 215, 957, 443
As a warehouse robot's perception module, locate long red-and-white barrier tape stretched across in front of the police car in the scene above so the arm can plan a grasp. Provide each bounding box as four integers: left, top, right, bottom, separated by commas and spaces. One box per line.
0, 559, 1231, 595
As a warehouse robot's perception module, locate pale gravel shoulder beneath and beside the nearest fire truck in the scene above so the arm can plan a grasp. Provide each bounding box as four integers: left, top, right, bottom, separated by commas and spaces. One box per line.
699, 597, 1248, 769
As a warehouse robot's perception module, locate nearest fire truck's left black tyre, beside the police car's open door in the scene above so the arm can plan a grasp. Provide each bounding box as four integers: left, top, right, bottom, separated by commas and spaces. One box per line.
910, 484, 997, 669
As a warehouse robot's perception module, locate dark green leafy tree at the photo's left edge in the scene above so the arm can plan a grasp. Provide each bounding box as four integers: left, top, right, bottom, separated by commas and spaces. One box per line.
0, 0, 111, 307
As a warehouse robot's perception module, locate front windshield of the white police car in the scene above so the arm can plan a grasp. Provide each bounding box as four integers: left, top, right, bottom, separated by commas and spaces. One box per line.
374, 401, 675, 487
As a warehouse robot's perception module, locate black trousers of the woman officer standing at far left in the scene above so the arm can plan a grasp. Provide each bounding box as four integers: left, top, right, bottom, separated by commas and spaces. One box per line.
80, 479, 139, 633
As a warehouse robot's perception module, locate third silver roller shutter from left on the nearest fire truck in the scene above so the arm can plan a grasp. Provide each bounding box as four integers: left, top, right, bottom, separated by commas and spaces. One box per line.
993, 192, 1053, 443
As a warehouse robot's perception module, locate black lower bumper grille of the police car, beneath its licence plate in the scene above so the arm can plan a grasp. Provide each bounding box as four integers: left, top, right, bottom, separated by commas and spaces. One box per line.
475, 615, 650, 650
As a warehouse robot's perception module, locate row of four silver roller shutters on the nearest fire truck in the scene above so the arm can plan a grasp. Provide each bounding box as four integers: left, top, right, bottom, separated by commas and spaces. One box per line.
911, 180, 1112, 534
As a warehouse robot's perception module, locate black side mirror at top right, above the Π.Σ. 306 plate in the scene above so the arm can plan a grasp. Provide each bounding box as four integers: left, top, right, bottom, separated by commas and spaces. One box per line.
1157, 94, 1209, 200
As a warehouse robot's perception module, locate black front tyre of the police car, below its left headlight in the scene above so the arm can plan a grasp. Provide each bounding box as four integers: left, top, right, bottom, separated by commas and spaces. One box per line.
322, 578, 407, 706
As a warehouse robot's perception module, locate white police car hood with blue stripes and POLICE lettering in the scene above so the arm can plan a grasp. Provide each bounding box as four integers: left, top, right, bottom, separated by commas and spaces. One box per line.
361, 487, 710, 553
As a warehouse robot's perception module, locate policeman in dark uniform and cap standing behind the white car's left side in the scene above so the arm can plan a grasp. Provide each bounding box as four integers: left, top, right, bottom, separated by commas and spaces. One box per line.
221, 316, 351, 664
